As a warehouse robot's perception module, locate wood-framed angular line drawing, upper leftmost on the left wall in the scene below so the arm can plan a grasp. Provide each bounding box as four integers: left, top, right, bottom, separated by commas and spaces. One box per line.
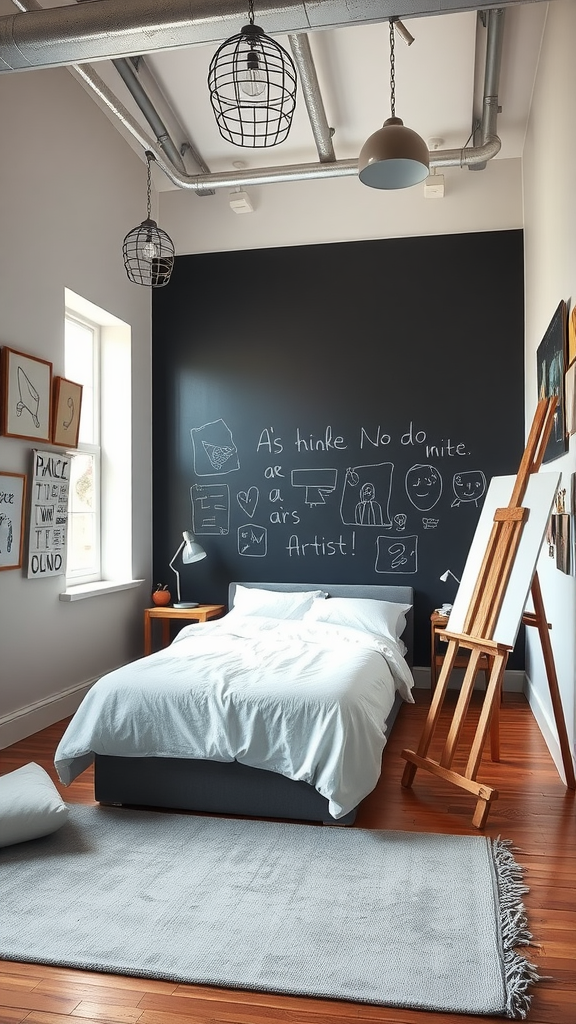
0, 346, 52, 441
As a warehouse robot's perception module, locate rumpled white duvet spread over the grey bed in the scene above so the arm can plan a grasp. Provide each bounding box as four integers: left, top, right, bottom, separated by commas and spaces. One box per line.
54, 612, 413, 818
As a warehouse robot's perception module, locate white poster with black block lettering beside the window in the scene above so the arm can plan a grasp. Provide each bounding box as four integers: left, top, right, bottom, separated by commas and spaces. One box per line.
28, 449, 71, 580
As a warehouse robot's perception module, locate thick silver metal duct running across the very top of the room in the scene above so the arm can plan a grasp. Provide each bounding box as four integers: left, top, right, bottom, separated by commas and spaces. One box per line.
0, 0, 518, 71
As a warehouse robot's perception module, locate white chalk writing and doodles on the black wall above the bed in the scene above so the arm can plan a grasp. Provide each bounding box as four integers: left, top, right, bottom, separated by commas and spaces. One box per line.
190, 418, 486, 574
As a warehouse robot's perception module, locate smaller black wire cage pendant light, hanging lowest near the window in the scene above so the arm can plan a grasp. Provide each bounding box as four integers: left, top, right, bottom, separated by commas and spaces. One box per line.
122, 152, 174, 288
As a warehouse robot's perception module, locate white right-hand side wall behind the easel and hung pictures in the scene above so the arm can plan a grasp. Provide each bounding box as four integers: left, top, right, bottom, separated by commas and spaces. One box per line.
523, 0, 576, 782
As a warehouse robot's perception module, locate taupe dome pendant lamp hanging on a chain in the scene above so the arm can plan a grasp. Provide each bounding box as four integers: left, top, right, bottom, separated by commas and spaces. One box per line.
358, 17, 429, 188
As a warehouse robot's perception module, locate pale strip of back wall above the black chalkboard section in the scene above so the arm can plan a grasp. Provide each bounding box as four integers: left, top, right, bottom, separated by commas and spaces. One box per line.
160, 160, 522, 260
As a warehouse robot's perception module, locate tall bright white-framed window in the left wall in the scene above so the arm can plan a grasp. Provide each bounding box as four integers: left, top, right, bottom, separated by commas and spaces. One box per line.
60, 289, 137, 601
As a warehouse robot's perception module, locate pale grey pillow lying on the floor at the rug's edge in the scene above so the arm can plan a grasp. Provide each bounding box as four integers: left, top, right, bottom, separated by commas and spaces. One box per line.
0, 762, 68, 847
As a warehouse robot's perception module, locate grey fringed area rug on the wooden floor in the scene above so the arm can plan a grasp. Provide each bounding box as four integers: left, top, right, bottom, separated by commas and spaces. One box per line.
0, 806, 538, 1018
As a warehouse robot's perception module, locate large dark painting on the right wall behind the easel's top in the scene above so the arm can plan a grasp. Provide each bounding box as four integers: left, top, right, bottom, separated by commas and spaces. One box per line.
536, 299, 568, 462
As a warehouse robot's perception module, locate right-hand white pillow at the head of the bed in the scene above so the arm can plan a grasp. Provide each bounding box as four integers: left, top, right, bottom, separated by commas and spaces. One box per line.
304, 597, 412, 640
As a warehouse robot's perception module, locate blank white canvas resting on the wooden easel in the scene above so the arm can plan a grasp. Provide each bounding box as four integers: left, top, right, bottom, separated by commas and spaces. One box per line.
446, 473, 561, 647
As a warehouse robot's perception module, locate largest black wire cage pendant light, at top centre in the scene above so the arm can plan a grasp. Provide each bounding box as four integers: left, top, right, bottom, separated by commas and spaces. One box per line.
208, 0, 296, 148
